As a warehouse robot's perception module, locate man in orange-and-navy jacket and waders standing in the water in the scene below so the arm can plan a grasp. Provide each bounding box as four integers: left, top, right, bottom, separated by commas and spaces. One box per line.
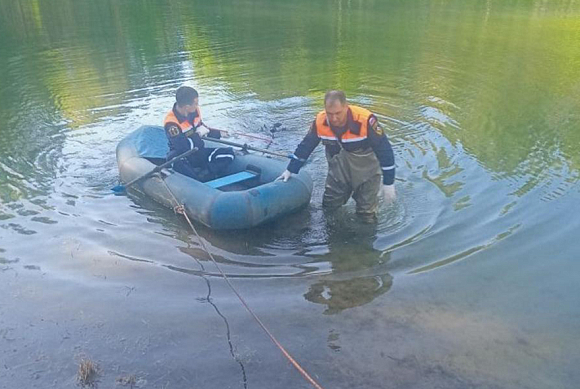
278, 90, 396, 221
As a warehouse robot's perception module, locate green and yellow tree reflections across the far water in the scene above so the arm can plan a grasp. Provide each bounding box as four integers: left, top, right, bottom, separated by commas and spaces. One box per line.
0, 0, 580, 190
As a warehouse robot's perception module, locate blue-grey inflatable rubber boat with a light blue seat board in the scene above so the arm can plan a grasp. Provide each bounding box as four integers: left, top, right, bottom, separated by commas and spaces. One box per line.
117, 126, 312, 230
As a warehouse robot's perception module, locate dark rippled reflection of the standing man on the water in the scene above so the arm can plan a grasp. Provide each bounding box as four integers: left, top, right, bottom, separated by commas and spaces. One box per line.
304, 209, 393, 315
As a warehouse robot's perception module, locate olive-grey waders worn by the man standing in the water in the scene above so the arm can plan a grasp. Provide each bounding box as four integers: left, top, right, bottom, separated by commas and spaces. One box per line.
322, 141, 382, 216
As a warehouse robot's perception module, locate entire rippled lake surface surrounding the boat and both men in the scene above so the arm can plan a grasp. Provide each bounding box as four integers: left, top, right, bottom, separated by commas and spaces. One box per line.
0, 0, 580, 389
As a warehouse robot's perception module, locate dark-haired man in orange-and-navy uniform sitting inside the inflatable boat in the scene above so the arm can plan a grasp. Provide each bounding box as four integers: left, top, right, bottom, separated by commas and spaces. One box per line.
163, 86, 234, 181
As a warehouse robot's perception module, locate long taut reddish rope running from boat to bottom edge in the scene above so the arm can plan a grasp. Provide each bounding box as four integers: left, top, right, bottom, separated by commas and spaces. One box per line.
160, 176, 323, 389
